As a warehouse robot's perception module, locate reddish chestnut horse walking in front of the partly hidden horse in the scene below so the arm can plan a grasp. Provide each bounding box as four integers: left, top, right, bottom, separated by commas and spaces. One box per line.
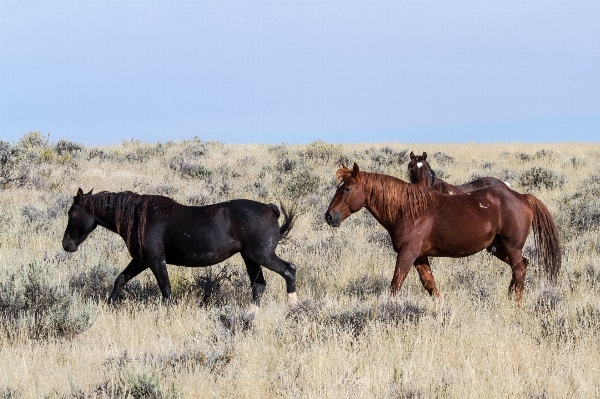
325, 163, 561, 302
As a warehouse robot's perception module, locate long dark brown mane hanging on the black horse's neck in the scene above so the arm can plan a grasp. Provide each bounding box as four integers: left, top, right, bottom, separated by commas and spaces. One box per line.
80, 191, 178, 256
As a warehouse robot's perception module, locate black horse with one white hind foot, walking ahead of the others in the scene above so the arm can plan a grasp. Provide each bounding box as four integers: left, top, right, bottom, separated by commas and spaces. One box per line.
63, 188, 297, 305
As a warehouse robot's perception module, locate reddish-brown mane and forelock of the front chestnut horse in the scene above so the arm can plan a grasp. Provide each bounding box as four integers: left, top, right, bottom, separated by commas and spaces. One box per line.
336, 168, 438, 221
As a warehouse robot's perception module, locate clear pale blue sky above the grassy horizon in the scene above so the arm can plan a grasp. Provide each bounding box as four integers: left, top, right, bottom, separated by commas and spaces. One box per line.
0, 0, 600, 144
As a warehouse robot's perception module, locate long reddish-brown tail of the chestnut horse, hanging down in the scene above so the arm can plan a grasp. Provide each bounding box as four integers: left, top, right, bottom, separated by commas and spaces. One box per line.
523, 194, 561, 283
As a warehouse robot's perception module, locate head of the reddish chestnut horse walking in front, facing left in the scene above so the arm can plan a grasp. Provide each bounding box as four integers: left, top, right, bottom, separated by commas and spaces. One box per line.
325, 162, 367, 227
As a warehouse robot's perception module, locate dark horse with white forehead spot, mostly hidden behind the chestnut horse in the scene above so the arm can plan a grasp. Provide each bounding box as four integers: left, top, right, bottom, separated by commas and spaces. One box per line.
408, 151, 510, 194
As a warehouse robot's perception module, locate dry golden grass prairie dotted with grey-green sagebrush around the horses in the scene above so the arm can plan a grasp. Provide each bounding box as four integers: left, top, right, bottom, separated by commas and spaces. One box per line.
0, 132, 600, 398
